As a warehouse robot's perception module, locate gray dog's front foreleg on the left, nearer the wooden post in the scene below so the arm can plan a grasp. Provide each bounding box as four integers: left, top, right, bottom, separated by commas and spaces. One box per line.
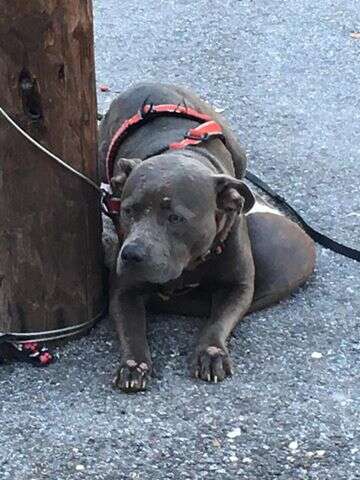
110, 289, 151, 392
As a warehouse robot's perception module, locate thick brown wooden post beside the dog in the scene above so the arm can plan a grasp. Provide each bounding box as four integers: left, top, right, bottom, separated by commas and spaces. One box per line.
0, 0, 103, 333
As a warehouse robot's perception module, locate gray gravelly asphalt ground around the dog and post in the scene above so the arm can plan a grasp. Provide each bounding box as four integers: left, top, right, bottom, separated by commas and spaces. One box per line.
0, 0, 360, 480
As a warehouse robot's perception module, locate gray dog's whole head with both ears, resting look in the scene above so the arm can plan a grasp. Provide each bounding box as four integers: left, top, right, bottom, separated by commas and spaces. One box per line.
111, 152, 254, 283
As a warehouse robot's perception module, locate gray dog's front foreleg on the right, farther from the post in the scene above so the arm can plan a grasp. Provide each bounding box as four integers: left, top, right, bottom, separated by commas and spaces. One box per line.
191, 282, 254, 383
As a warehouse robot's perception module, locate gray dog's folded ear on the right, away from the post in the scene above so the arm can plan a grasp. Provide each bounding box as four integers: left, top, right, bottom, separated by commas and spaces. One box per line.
213, 175, 255, 213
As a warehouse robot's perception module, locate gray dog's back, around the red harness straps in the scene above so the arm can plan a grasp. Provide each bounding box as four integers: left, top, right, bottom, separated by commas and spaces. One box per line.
99, 83, 246, 182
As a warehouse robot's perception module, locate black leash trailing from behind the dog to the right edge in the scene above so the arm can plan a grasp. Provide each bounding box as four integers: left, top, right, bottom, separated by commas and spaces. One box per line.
245, 172, 360, 262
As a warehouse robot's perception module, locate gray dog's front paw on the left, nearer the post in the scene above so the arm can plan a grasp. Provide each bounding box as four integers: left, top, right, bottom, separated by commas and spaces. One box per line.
113, 359, 151, 393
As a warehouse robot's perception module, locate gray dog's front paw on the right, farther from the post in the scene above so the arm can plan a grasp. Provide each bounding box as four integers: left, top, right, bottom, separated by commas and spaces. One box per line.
191, 345, 232, 383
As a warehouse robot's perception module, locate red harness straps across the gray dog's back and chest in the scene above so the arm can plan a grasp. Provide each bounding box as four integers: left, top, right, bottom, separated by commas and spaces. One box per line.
104, 104, 224, 219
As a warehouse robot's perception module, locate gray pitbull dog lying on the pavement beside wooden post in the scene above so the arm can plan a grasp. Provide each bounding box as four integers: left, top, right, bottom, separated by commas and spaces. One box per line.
99, 83, 314, 392
